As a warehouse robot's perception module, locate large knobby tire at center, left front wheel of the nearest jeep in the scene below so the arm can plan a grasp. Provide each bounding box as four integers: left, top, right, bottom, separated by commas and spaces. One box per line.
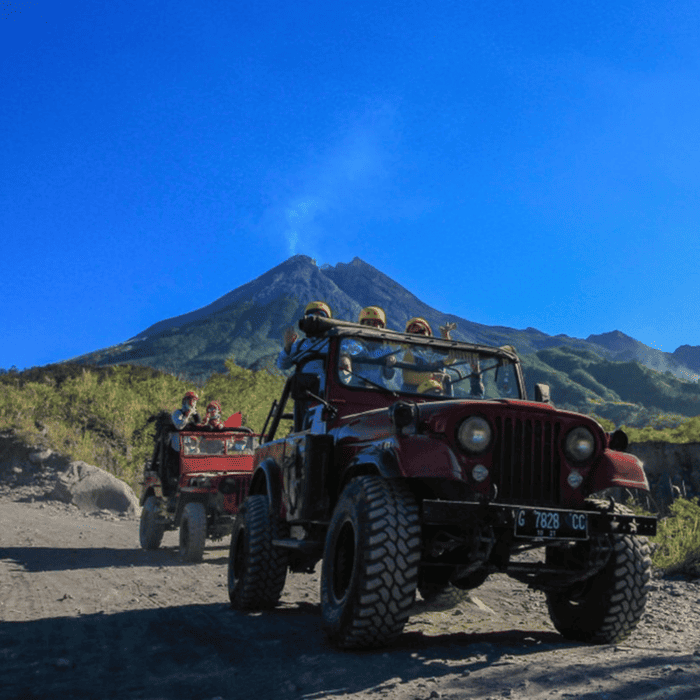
321, 476, 421, 649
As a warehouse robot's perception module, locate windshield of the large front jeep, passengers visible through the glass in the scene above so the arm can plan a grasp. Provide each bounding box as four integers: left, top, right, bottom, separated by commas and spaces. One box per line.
336, 334, 522, 400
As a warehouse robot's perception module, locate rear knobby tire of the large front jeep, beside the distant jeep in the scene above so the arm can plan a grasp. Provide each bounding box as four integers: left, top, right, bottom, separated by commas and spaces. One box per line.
228, 496, 287, 610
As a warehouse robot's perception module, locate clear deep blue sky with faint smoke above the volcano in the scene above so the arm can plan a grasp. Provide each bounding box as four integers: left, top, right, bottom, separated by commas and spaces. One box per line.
0, 0, 700, 369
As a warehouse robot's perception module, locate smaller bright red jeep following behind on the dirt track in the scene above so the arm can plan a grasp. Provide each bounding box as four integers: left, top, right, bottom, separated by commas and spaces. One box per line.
139, 413, 259, 562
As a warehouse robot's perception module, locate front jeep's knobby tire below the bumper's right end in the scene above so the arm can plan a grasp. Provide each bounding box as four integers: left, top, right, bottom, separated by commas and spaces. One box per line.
546, 535, 651, 644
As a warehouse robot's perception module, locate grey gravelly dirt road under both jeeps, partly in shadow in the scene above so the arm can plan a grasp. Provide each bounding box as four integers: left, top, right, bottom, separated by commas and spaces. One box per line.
0, 488, 700, 700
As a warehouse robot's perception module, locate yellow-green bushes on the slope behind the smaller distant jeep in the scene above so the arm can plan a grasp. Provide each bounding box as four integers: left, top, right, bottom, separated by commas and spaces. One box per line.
0, 358, 284, 493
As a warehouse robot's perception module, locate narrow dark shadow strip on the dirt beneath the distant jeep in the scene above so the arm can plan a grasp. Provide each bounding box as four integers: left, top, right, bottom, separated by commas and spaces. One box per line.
0, 547, 228, 572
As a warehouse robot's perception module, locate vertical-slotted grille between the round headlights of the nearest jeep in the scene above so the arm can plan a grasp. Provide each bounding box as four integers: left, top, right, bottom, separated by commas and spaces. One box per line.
493, 416, 561, 506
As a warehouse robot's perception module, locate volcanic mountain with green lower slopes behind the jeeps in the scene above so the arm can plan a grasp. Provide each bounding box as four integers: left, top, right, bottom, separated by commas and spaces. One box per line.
65, 255, 700, 422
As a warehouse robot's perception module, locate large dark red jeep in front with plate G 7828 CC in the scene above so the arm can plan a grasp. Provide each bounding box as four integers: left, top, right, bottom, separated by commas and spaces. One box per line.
228, 317, 656, 649
